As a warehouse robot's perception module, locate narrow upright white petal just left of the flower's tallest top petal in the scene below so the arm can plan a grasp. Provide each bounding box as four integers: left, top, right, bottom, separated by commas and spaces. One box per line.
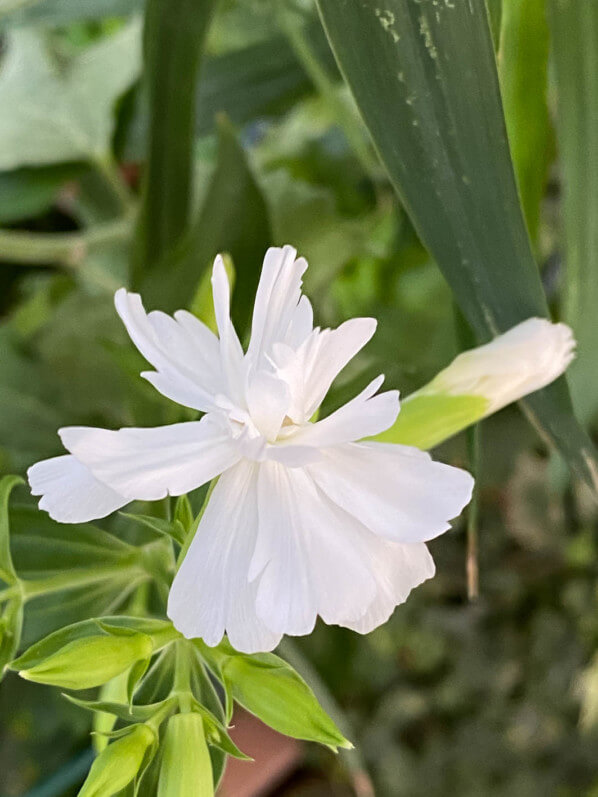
212, 255, 245, 404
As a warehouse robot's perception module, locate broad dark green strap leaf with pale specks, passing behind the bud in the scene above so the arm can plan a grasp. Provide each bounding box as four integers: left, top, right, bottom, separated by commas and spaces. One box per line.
318, 0, 598, 488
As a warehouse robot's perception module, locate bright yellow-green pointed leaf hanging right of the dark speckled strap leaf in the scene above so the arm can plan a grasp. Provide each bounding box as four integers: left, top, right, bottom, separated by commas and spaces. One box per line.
499, 0, 550, 240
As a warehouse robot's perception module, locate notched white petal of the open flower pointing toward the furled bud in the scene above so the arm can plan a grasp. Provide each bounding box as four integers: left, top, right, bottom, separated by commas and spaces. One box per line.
288, 376, 399, 448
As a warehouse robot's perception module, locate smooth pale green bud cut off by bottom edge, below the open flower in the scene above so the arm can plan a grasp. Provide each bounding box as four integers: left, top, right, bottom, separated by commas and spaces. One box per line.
158, 713, 214, 797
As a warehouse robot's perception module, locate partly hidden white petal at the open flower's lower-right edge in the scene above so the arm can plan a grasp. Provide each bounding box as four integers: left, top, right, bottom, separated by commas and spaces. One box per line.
339, 536, 435, 634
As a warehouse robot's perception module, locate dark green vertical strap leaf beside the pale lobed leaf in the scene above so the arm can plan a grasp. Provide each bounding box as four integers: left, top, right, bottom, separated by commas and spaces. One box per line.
133, 0, 220, 282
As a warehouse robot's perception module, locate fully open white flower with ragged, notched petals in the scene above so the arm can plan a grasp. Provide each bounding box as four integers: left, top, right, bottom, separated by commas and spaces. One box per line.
29, 246, 473, 652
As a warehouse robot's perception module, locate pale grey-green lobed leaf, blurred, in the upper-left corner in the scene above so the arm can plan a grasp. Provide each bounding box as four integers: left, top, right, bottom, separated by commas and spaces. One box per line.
0, 21, 141, 170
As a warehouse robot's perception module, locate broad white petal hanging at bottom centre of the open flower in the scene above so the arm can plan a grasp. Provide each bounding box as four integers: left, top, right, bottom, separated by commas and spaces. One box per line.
249, 462, 376, 635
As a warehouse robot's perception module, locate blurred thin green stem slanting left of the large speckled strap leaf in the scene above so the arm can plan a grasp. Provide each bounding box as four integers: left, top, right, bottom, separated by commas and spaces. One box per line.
277, 2, 380, 175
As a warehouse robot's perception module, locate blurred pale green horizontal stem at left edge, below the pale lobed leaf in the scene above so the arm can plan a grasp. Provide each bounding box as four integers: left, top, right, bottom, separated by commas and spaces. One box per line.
0, 219, 132, 269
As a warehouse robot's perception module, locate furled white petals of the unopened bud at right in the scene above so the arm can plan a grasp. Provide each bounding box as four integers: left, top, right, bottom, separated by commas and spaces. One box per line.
422, 318, 575, 415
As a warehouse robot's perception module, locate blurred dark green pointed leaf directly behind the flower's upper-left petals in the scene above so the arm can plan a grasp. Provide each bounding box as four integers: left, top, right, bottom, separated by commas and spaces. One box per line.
142, 120, 271, 331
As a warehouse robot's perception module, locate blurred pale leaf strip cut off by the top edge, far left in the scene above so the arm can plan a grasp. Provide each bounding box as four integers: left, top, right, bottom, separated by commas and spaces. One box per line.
0, 0, 144, 26
